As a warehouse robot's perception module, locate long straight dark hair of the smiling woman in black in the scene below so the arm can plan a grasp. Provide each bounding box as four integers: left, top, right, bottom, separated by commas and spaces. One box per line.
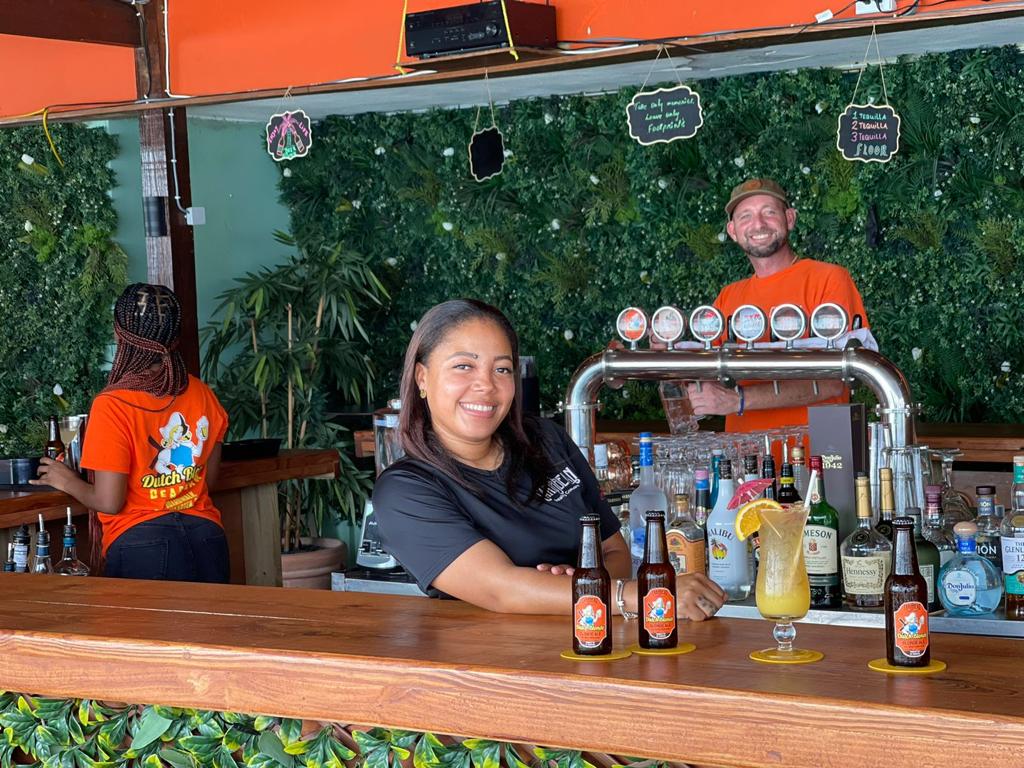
399, 299, 553, 504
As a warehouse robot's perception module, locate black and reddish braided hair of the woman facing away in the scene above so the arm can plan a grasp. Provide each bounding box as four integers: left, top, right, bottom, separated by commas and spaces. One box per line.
103, 283, 188, 397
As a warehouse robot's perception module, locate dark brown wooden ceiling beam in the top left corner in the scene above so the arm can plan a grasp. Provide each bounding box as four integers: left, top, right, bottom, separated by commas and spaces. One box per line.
0, 0, 139, 47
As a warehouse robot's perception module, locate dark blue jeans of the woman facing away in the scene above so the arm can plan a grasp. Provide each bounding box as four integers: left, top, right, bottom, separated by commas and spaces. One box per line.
103, 512, 230, 584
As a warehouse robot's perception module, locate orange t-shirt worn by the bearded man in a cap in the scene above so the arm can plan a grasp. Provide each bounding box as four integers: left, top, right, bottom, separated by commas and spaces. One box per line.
715, 259, 868, 432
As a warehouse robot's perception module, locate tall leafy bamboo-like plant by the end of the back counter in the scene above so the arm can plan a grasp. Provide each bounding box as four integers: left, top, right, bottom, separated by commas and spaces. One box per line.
203, 232, 388, 586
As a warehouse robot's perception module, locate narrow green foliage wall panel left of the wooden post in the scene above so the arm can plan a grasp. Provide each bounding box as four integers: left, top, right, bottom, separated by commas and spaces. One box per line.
0, 125, 126, 456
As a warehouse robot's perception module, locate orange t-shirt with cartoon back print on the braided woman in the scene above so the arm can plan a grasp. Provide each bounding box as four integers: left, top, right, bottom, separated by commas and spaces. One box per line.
81, 376, 227, 554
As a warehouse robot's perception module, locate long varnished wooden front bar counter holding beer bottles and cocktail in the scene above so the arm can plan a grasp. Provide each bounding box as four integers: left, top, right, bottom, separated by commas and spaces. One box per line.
0, 573, 1024, 768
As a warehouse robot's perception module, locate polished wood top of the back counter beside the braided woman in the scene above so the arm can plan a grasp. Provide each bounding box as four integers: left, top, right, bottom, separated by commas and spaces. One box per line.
0, 450, 340, 527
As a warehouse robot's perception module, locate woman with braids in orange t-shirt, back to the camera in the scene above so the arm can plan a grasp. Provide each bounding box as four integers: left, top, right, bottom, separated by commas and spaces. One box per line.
35, 283, 228, 583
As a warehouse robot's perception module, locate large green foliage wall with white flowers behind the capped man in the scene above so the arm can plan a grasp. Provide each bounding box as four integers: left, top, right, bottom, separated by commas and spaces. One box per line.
281, 48, 1024, 422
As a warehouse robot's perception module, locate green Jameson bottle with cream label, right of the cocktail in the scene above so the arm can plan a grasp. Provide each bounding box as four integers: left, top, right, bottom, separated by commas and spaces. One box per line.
804, 456, 843, 608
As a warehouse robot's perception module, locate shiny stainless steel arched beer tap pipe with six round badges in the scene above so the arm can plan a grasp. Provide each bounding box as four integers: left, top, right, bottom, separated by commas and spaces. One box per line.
565, 345, 914, 455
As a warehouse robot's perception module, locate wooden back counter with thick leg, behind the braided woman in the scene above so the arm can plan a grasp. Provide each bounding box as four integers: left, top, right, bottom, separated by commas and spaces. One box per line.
0, 450, 339, 587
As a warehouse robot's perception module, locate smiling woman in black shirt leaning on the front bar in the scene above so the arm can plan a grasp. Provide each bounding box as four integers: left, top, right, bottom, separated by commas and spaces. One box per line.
373, 299, 725, 621
